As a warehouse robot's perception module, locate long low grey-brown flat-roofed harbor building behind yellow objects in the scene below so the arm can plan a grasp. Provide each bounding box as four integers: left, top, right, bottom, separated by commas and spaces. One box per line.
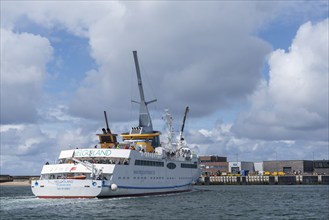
263, 160, 313, 174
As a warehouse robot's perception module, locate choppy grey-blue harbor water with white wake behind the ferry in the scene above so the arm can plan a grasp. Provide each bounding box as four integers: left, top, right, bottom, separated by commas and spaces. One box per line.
0, 185, 329, 220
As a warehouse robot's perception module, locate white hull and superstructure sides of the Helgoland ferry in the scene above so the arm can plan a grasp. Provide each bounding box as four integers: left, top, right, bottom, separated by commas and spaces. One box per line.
31, 149, 200, 198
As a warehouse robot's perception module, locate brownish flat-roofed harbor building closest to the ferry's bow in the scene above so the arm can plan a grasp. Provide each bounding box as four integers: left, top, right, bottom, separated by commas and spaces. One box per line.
199, 156, 228, 176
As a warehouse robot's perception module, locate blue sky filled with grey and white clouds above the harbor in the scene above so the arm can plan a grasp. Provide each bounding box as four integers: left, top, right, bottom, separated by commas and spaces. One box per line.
0, 0, 329, 175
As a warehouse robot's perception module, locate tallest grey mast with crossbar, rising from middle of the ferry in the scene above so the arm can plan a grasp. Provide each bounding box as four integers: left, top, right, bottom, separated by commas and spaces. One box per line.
132, 51, 157, 133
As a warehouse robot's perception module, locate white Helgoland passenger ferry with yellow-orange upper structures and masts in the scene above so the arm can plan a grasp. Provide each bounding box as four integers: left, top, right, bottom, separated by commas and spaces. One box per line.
31, 51, 200, 198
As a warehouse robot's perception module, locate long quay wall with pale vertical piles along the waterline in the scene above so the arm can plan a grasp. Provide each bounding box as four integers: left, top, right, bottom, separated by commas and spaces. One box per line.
199, 175, 329, 185
